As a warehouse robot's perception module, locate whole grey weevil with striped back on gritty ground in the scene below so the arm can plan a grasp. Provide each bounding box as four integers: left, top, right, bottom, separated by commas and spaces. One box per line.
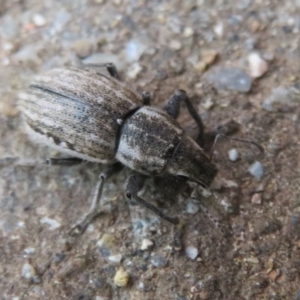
20, 63, 260, 234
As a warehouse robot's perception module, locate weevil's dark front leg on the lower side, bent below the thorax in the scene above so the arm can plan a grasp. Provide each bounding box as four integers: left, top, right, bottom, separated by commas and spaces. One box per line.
126, 174, 179, 225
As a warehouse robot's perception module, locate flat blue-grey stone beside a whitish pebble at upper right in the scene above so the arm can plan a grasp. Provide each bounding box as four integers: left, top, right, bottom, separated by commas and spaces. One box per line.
207, 67, 252, 93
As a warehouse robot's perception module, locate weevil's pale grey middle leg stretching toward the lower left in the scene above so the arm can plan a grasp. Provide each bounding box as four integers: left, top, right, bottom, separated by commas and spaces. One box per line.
69, 162, 123, 236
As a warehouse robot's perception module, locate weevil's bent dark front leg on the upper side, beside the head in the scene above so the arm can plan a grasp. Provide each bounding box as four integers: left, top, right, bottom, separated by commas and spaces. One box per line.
164, 90, 204, 147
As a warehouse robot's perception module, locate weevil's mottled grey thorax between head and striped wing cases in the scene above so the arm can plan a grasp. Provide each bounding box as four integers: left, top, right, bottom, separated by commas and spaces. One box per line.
116, 106, 183, 176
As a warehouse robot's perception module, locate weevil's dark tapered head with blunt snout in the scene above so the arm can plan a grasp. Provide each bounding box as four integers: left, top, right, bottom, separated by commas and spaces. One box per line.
166, 136, 218, 188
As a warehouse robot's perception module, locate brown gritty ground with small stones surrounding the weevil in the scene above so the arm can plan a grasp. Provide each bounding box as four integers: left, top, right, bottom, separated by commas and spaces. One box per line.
0, 0, 300, 300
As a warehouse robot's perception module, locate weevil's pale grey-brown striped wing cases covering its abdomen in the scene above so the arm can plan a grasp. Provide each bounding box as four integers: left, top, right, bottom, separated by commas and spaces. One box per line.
20, 68, 143, 163
